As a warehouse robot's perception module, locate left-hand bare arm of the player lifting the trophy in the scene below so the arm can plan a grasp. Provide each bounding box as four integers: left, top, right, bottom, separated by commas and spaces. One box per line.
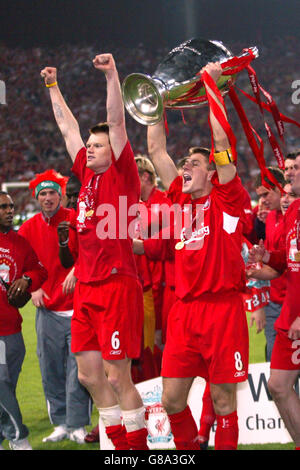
147, 120, 178, 189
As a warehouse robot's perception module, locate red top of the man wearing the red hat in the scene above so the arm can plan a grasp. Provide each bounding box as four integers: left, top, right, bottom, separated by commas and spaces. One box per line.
19, 207, 76, 312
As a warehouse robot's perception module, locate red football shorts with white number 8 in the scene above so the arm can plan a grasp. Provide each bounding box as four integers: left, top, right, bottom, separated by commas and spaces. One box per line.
161, 293, 249, 384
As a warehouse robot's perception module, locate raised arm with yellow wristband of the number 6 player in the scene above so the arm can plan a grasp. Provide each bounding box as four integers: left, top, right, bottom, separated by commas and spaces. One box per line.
41, 67, 84, 161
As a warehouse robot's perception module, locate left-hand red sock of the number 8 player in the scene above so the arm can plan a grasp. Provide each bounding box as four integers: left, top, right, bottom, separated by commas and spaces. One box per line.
168, 406, 200, 450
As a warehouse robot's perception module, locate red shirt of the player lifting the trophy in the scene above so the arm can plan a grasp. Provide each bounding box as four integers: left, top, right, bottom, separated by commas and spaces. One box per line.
164, 175, 245, 299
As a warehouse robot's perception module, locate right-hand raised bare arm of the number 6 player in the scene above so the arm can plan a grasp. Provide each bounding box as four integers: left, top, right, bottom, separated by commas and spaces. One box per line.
93, 54, 127, 159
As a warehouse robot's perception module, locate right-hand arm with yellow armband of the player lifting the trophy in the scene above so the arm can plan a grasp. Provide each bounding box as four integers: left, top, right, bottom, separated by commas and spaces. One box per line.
201, 62, 236, 184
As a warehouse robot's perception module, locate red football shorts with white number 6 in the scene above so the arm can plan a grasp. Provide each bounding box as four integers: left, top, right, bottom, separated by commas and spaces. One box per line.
71, 274, 144, 360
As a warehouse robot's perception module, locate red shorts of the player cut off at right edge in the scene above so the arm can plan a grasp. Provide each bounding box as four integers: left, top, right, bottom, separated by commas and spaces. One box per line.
270, 330, 300, 370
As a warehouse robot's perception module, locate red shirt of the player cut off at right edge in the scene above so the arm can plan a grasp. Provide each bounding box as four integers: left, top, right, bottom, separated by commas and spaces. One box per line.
269, 200, 300, 331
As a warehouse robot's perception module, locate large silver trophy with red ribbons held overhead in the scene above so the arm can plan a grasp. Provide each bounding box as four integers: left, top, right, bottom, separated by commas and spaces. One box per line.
122, 39, 258, 125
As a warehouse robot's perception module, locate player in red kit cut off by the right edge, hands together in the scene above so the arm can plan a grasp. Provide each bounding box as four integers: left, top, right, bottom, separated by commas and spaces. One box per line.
250, 155, 300, 449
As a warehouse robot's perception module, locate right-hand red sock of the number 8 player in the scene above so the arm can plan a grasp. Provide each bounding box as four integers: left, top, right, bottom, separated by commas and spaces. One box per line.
215, 411, 239, 450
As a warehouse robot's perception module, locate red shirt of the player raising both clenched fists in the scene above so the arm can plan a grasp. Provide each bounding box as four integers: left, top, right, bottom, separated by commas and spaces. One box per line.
72, 141, 140, 283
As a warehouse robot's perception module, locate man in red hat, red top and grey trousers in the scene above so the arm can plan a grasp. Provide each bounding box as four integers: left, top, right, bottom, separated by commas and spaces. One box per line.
19, 169, 91, 443
